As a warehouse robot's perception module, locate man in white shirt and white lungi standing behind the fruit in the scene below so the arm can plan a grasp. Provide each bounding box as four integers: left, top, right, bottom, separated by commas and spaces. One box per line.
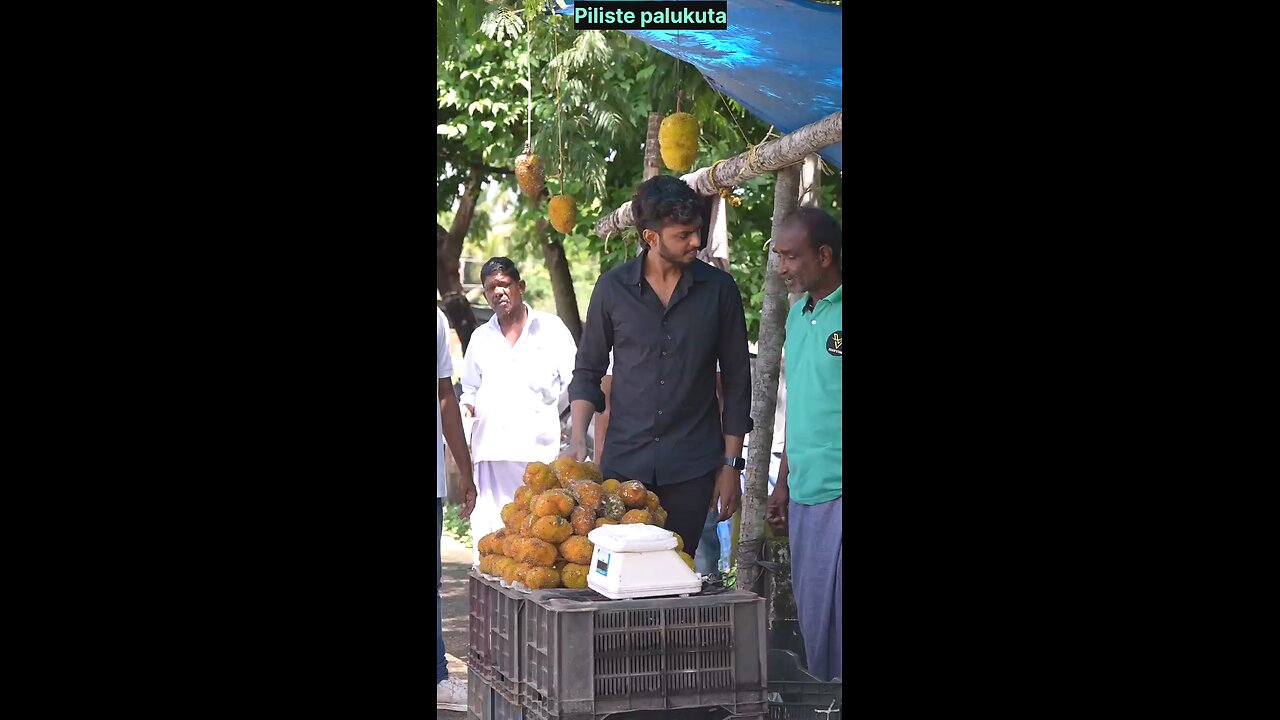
462, 258, 577, 561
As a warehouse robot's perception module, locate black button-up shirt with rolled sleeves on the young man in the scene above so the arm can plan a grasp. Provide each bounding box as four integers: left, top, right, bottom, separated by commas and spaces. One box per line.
568, 250, 751, 486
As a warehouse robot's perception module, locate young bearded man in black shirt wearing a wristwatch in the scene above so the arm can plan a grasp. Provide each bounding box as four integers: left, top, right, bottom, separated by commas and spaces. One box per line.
563, 176, 751, 557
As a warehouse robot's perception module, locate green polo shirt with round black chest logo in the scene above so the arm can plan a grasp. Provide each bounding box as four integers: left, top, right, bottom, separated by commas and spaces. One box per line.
785, 286, 845, 505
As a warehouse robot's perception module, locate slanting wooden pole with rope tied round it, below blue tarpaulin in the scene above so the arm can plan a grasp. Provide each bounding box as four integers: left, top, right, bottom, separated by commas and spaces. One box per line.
595, 111, 844, 237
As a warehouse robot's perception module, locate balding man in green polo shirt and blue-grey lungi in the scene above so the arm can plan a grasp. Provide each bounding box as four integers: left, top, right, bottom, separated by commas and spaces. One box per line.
768, 208, 845, 680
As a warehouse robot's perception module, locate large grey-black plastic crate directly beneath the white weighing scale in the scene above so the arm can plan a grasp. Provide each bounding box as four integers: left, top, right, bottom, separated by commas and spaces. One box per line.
520, 591, 768, 720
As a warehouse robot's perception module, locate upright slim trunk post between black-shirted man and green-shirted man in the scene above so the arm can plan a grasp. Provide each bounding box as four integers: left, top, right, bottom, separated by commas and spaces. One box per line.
737, 165, 800, 594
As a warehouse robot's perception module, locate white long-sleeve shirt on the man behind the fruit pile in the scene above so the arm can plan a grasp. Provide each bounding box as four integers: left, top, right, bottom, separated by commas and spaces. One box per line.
462, 304, 577, 462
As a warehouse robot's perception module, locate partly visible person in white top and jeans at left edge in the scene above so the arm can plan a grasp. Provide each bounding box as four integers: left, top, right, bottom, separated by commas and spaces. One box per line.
435, 307, 476, 712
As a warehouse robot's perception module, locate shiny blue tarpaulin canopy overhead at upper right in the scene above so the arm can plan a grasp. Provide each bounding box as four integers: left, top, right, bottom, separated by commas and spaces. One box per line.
561, 0, 844, 169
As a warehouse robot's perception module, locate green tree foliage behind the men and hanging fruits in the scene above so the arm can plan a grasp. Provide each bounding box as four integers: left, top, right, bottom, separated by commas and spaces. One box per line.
436, 0, 841, 340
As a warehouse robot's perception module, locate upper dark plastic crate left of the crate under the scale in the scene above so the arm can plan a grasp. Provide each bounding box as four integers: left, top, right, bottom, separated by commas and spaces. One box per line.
467, 569, 526, 698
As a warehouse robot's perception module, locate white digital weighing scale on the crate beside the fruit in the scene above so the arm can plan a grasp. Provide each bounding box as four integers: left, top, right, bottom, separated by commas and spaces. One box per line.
586, 524, 703, 600
